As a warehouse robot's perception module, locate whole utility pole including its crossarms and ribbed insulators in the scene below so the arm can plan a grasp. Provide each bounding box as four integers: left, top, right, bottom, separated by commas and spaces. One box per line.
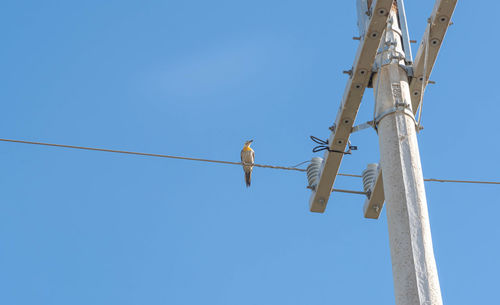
307, 0, 457, 305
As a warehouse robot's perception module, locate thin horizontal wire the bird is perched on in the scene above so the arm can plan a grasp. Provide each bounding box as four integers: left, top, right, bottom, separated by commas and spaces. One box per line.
0, 138, 500, 184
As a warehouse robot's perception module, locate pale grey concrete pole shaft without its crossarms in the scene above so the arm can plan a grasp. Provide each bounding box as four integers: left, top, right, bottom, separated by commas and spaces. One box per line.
373, 5, 443, 305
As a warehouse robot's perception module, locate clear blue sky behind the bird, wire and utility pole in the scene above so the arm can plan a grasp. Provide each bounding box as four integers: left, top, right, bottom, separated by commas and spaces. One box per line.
0, 0, 500, 305
